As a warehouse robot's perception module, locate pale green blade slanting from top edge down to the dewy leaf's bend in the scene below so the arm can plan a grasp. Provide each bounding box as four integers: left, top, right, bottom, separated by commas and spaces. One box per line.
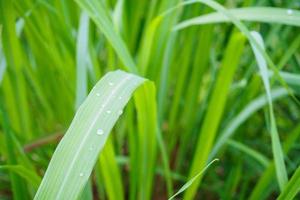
75, 0, 137, 73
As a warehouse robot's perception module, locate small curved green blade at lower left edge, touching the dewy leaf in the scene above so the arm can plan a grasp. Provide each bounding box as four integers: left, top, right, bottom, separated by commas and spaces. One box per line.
0, 165, 41, 189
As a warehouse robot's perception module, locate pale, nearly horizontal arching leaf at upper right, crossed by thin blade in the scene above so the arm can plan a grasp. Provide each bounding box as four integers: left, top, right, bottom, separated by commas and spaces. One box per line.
174, 7, 300, 30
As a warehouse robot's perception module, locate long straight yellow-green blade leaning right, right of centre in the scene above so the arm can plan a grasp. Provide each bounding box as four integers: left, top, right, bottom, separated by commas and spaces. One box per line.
184, 34, 245, 200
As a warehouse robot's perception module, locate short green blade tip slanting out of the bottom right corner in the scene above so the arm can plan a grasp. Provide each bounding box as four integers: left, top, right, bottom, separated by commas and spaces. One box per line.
278, 166, 300, 200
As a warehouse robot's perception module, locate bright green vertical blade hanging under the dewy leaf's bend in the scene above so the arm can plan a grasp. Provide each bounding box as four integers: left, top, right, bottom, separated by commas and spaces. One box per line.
134, 84, 159, 200
